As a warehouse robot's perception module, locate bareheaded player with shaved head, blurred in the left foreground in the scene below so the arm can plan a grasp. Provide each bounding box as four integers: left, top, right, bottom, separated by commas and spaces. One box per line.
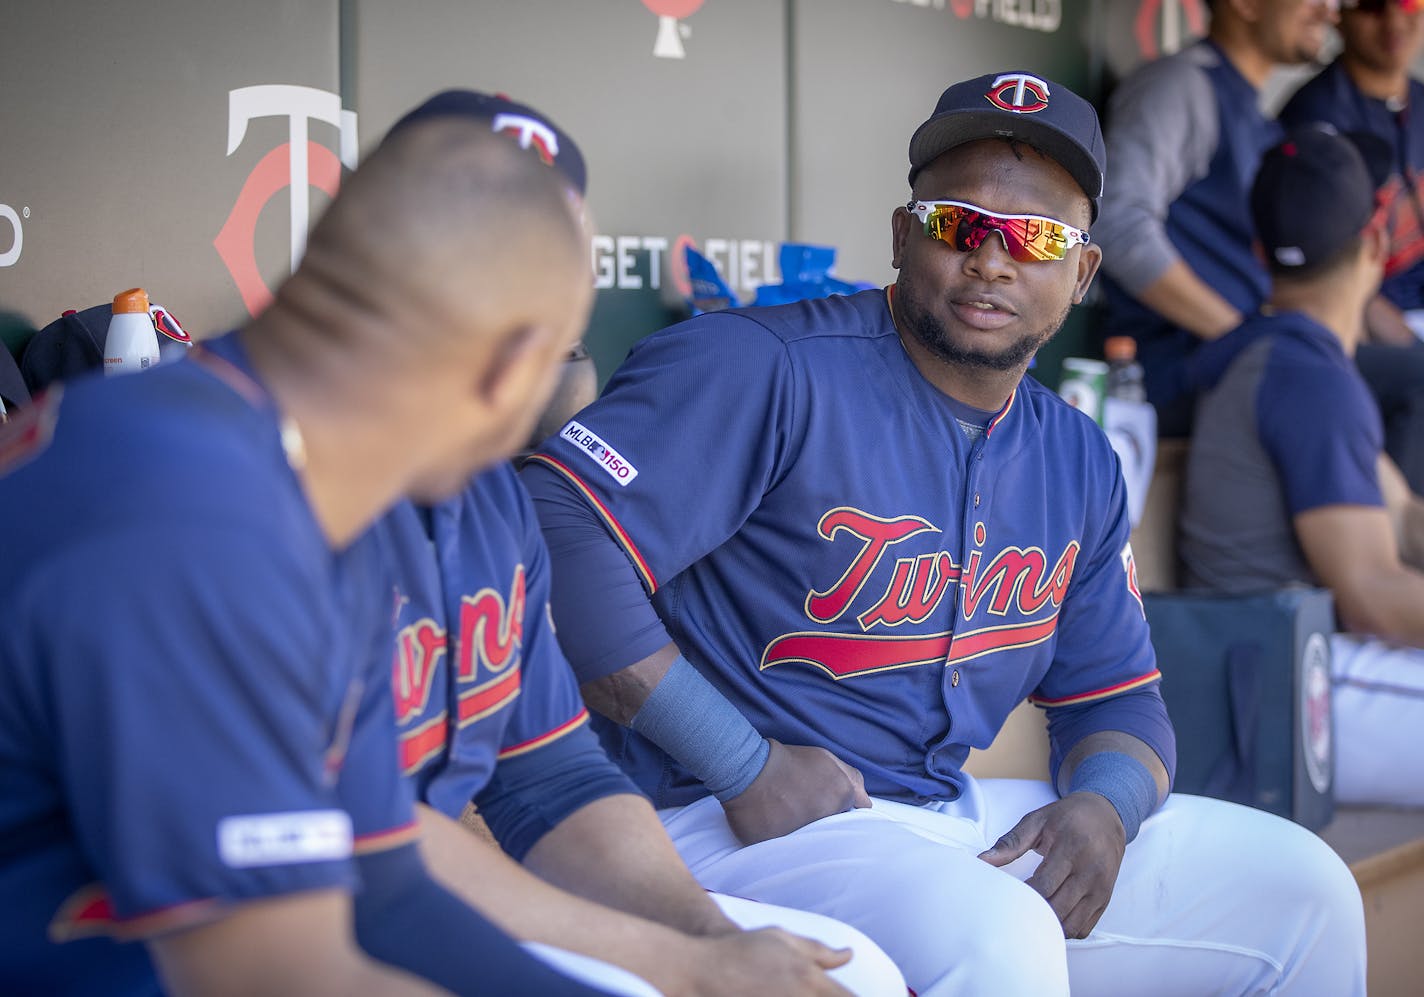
0, 97, 612, 994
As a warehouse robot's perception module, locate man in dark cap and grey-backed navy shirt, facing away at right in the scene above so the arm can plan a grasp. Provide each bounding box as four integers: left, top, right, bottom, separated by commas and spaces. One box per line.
1179, 127, 1424, 806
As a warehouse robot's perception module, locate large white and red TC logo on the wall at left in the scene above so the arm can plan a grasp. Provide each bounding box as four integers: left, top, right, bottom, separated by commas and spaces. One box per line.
212, 84, 356, 315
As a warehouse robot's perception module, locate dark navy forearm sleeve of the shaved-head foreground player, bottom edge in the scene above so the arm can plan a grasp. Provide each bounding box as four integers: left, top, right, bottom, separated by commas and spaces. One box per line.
355, 845, 602, 997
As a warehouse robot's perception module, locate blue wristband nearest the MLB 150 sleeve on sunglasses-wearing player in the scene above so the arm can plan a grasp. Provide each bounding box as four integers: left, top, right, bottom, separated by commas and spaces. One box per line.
628, 655, 772, 803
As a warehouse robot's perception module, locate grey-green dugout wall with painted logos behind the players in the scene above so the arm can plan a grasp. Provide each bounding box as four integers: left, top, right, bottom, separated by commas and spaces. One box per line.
0, 0, 1205, 376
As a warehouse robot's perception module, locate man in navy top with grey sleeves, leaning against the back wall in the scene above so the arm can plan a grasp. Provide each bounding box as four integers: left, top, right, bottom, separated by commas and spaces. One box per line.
1094, 0, 1336, 436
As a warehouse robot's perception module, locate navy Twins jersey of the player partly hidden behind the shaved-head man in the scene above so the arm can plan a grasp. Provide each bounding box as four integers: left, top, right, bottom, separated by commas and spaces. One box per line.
376, 464, 588, 818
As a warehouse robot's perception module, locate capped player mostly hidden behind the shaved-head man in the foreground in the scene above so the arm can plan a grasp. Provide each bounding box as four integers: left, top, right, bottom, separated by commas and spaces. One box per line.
376, 91, 904, 997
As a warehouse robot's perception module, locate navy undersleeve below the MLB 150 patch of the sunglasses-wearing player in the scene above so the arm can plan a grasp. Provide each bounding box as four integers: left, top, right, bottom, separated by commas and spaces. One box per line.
520, 463, 672, 684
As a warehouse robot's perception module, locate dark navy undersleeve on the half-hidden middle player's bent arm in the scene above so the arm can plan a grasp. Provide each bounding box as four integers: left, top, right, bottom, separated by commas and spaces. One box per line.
474, 724, 641, 862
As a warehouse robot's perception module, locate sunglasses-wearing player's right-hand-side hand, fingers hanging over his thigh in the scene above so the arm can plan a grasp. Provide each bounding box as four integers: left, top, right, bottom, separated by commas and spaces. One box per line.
980, 792, 1128, 939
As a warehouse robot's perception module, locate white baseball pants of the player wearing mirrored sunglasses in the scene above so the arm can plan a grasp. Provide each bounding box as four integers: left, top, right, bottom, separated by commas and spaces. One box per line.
664, 781, 1364, 997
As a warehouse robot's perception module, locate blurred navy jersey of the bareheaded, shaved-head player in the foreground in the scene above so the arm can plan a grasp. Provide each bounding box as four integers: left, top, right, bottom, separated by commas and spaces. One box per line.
0, 336, 413, 994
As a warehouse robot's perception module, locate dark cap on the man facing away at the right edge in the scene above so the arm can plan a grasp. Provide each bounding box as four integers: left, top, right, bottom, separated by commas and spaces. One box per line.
1250, 125, 1378, 272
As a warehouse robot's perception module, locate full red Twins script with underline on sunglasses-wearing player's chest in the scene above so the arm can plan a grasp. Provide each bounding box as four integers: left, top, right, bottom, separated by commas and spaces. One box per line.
760, 507, 1079, 679
